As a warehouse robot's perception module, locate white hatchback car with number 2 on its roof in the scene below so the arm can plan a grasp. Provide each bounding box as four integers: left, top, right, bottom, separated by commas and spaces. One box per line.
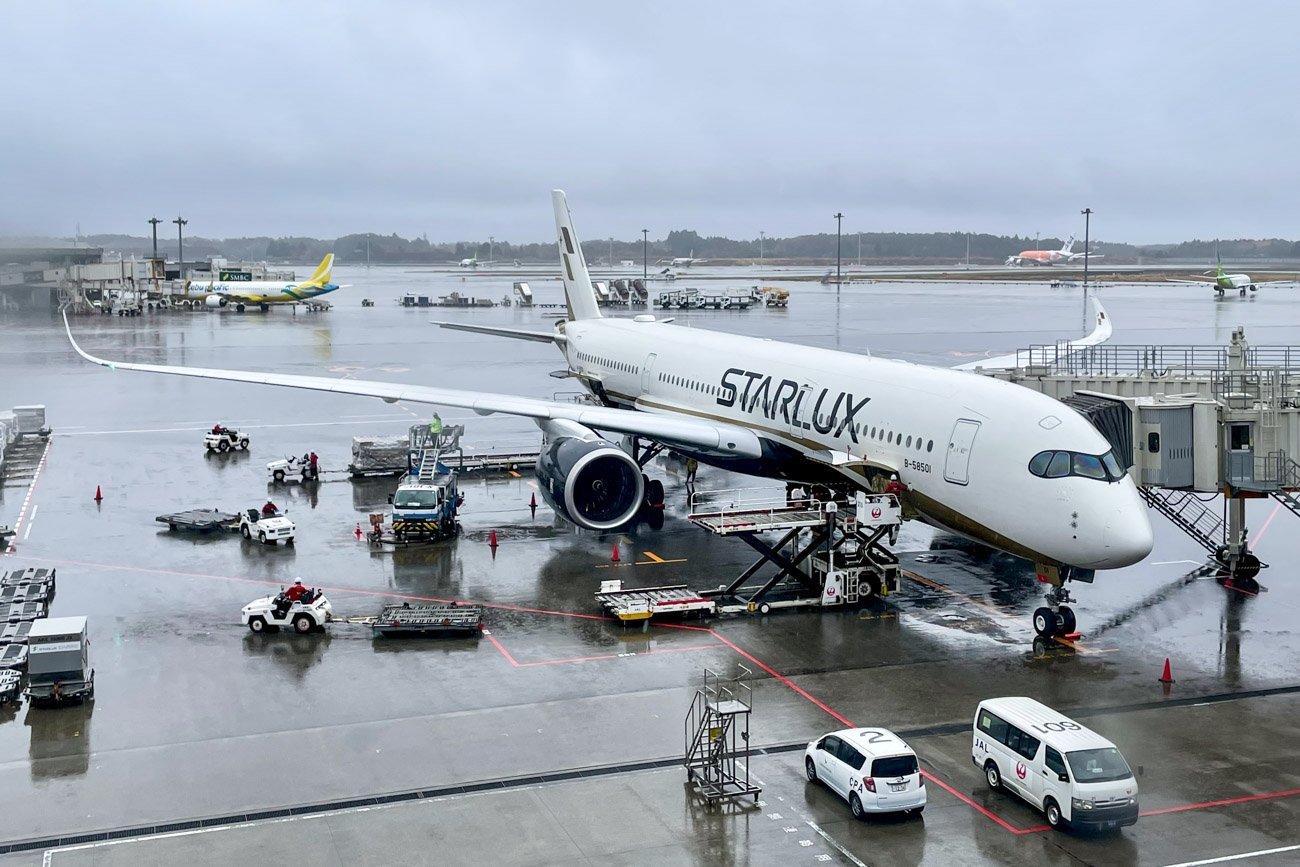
803, 728, 926, 819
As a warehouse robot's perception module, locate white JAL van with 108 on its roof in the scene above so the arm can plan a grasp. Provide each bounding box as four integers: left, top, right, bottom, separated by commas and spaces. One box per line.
971, 698, 1138, 831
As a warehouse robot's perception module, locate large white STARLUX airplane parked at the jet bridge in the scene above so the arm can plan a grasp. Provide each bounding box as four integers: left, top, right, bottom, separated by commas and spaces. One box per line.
65, 190, 1152, 634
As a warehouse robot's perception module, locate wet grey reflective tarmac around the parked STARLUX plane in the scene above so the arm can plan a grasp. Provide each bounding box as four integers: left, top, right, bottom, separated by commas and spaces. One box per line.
0, 268, 1300, 864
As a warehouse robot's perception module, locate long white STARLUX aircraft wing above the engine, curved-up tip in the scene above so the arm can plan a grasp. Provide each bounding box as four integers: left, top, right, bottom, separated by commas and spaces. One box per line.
64, 313, 763, 458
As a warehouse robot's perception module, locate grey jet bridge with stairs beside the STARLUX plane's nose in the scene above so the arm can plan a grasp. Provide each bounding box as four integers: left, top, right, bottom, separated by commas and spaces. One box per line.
976, 328, 1300, 591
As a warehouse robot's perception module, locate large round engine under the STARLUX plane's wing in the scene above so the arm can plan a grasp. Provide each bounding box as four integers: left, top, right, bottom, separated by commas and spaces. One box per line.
537, 420, 645, 530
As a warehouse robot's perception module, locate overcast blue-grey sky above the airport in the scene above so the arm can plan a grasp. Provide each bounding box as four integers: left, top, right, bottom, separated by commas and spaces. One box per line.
0, 0, 1300, 243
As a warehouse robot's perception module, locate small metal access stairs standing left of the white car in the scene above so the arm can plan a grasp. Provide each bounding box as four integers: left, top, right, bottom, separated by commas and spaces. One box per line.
685, 666, 762, 806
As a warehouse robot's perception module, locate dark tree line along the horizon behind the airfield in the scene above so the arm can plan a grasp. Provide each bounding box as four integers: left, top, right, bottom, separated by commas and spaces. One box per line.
79, 230, 1300, 264
